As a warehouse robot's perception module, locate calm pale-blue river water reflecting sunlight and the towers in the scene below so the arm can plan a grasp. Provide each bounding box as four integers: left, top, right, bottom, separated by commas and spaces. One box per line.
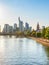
0, 36, 49, 65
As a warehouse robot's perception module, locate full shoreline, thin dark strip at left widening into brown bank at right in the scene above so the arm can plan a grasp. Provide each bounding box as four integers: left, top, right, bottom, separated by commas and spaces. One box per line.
1, 35, 49, 47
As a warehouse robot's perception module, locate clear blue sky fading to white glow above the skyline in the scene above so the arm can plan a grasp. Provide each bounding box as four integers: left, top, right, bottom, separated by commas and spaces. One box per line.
0, 0, 49, 29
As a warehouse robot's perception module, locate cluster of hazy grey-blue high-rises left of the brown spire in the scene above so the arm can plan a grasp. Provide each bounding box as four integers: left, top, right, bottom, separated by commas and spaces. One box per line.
0, 17, 32, 33
